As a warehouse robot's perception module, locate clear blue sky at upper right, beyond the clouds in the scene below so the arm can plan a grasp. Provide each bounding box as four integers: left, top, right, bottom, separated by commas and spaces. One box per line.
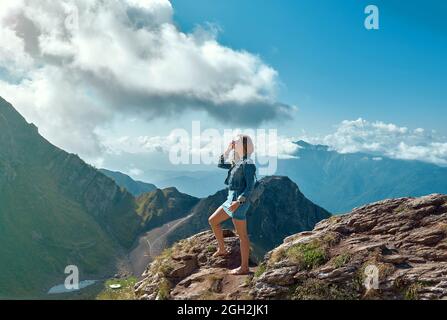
172, 0, 447, 135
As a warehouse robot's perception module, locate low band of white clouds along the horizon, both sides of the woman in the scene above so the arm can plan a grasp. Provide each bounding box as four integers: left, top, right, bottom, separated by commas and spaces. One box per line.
98, 119, 447, 166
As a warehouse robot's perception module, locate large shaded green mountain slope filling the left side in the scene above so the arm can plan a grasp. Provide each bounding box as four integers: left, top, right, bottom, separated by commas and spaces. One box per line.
0, 98, 142, 298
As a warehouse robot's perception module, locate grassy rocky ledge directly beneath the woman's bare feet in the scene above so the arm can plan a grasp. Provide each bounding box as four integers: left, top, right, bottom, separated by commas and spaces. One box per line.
135, 230, 251, 300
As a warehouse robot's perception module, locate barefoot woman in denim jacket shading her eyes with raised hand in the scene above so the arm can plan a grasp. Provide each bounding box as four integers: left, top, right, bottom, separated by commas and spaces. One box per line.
209, 135, 256, 275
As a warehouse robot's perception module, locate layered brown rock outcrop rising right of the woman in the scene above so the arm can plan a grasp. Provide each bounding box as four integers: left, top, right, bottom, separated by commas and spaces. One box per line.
250, 195, 447, 299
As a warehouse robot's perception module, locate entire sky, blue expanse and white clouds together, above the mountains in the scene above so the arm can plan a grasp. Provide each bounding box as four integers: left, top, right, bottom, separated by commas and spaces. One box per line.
0, 0, 447, 173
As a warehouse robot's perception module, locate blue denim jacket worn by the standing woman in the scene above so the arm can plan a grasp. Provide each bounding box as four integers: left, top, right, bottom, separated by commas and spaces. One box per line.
218, 157, 256, 200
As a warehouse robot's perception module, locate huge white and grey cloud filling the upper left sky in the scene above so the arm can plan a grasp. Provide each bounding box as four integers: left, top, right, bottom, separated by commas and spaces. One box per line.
0, 0, 292, 155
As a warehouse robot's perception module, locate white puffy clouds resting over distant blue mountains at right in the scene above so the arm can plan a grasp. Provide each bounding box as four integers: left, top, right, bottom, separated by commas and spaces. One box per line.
300, 118, 447, 166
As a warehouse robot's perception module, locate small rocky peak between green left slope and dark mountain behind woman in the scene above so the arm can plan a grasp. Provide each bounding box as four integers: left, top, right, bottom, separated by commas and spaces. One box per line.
137, 188, 199, 230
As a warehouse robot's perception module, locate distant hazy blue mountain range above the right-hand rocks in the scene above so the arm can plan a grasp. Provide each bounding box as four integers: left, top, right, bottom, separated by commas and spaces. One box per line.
278, 141, 447, 213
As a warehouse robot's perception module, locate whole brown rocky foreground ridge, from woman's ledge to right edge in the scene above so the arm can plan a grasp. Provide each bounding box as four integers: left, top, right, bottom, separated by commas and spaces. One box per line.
135, 195, 447, 300
